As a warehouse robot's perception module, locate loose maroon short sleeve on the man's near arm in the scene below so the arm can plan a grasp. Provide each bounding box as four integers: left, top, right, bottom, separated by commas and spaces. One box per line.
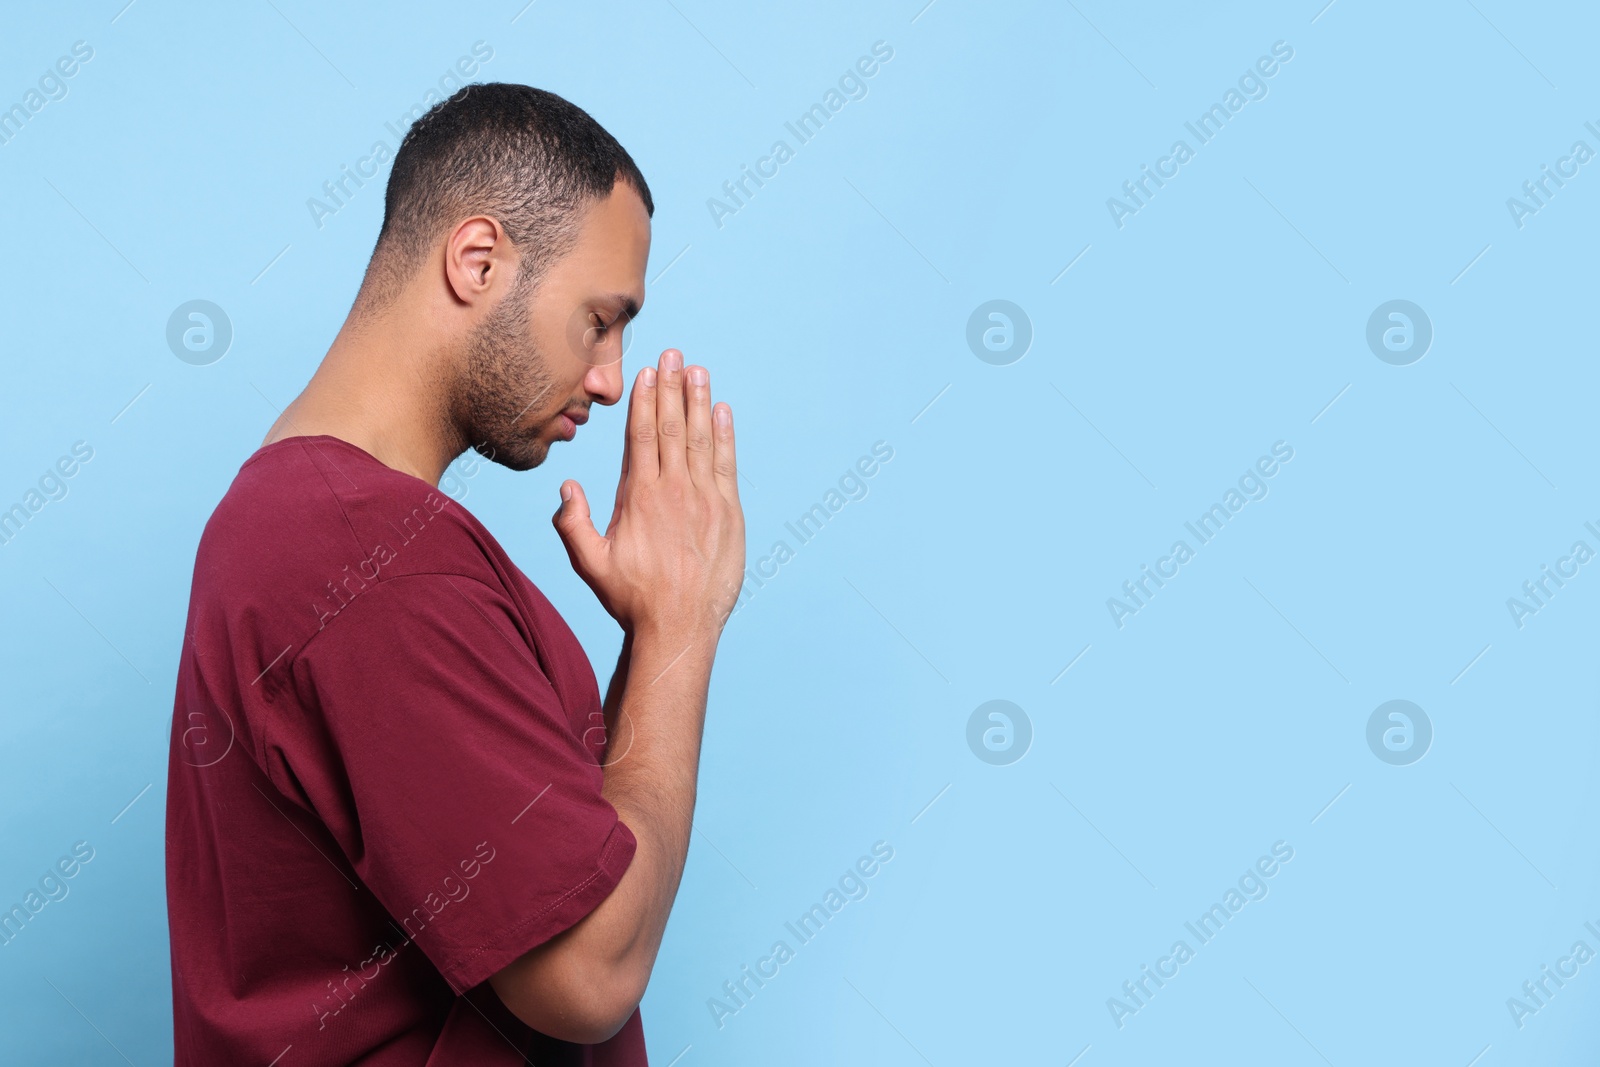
267, 574, 637, 993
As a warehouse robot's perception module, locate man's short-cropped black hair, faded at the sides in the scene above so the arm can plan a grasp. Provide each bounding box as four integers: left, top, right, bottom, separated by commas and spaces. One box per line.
363, 82, 656, 304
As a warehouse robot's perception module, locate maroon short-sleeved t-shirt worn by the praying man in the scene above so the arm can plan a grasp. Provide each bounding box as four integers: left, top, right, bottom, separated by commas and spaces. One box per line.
166, 437, 646, 1067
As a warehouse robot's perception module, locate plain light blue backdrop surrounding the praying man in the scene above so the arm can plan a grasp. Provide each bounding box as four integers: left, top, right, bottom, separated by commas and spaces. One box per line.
0, 0, 1600, 1067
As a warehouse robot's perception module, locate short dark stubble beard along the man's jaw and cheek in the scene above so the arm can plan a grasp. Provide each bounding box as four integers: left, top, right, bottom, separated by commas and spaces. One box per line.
451, 278, 555, 470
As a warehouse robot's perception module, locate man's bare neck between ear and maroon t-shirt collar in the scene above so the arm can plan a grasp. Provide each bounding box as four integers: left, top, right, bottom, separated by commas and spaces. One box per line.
261, 296, 469, 486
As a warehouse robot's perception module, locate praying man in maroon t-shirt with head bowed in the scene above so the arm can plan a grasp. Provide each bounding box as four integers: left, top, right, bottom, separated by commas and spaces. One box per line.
166, 85, 744, 1067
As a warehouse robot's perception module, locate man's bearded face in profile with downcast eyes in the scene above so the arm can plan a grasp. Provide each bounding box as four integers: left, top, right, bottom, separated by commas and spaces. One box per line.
454, 182, 650, 470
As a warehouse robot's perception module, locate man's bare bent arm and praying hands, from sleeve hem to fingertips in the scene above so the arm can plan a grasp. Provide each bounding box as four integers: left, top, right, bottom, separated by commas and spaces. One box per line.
505, 349, 744, 1043
